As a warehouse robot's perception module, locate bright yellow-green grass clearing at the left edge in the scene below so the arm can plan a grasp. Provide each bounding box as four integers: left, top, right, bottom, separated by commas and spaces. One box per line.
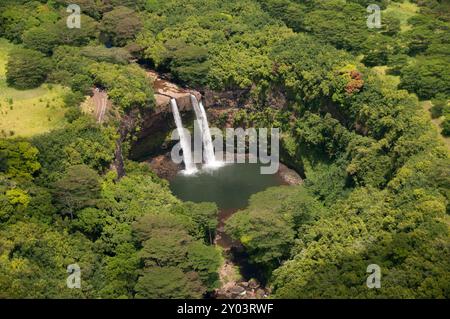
0, 39, 68, 137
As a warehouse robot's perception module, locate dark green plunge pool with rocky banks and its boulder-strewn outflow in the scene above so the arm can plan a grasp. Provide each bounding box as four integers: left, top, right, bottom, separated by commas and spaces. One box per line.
149, 155, 302, 299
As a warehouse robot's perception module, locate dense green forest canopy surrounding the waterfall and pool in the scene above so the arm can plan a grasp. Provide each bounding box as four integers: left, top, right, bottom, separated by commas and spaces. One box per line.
0, 0, 450, 298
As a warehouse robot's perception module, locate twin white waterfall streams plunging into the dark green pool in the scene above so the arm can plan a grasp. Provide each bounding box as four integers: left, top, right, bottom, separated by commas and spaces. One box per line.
170, 94, 218, 174
